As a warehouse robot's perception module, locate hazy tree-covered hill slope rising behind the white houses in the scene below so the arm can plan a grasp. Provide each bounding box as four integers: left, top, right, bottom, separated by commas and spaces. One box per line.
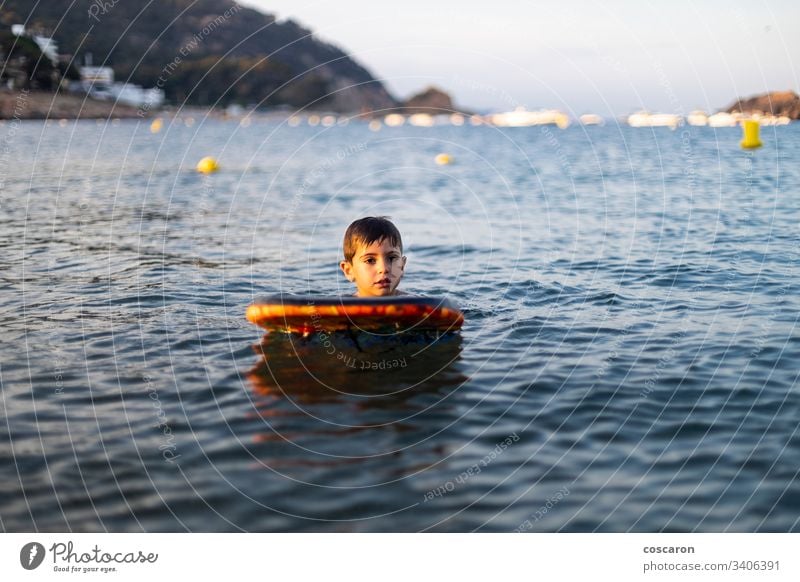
0, 0, 395, 112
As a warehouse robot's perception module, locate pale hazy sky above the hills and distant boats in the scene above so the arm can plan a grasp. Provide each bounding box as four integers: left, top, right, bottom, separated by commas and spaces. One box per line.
240, 0, 800, 116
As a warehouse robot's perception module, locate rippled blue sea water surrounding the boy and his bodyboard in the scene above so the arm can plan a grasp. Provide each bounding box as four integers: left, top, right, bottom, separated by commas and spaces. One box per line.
0, 120, 800, 531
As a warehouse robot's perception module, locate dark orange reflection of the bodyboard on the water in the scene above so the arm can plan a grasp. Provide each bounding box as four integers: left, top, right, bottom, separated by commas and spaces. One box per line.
247, 332, 468, 479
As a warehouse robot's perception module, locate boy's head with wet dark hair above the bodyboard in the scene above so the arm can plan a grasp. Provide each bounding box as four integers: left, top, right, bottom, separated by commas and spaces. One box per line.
339, 216, 406, 297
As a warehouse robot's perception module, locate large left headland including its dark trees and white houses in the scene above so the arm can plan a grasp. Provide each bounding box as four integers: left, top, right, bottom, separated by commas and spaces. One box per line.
0, 0, 397, 115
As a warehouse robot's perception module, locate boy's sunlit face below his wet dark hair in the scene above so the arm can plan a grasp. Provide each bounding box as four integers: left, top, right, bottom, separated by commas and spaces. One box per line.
339, 238, 406, 297
